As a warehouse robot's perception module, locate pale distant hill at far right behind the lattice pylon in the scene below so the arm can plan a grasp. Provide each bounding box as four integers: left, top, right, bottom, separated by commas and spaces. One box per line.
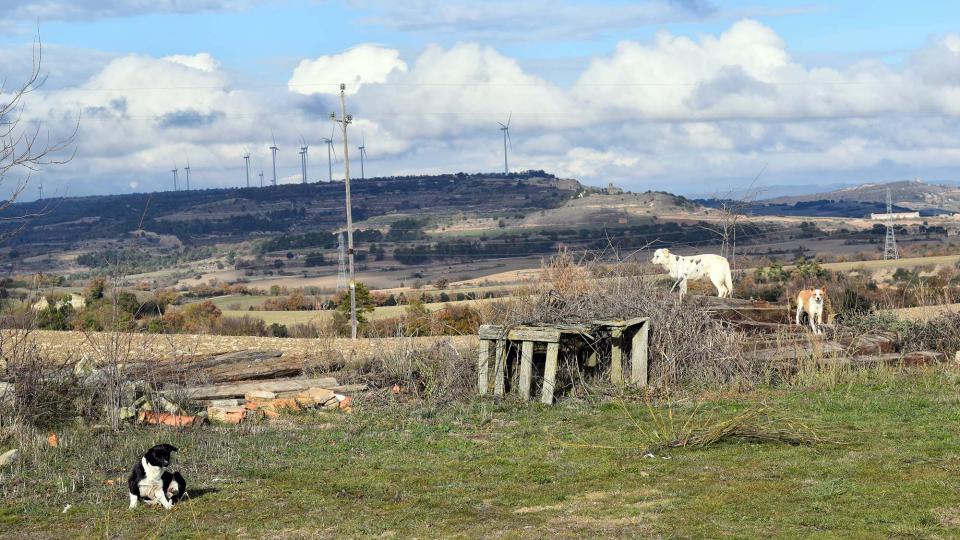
759, 180, 960, 215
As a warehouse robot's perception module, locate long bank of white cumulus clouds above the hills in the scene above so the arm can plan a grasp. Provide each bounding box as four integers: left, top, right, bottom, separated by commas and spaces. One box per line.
15, 20, 960, 198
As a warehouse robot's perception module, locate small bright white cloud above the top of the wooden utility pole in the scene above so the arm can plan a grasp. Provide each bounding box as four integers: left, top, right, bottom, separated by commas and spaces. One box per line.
287, 45, 407, 95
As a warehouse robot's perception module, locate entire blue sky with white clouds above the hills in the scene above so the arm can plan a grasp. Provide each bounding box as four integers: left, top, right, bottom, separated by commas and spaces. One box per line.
0, 0, 960, 199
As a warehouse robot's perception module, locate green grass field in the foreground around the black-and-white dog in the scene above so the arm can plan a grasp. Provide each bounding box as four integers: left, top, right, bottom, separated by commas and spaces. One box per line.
0, 371, 960, 538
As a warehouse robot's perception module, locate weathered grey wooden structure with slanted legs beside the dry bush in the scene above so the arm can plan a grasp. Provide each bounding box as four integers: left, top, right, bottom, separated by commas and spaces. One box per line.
477, 317, 650, 404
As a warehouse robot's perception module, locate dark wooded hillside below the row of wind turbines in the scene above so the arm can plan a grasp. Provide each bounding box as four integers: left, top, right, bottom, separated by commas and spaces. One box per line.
0, 171, 582, 251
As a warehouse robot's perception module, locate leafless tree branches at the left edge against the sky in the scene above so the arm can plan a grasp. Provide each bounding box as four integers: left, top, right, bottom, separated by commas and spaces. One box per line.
0, 32, 80, 240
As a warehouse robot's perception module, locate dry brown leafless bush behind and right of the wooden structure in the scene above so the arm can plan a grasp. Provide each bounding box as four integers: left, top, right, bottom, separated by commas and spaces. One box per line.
489, 253, 752, 387
